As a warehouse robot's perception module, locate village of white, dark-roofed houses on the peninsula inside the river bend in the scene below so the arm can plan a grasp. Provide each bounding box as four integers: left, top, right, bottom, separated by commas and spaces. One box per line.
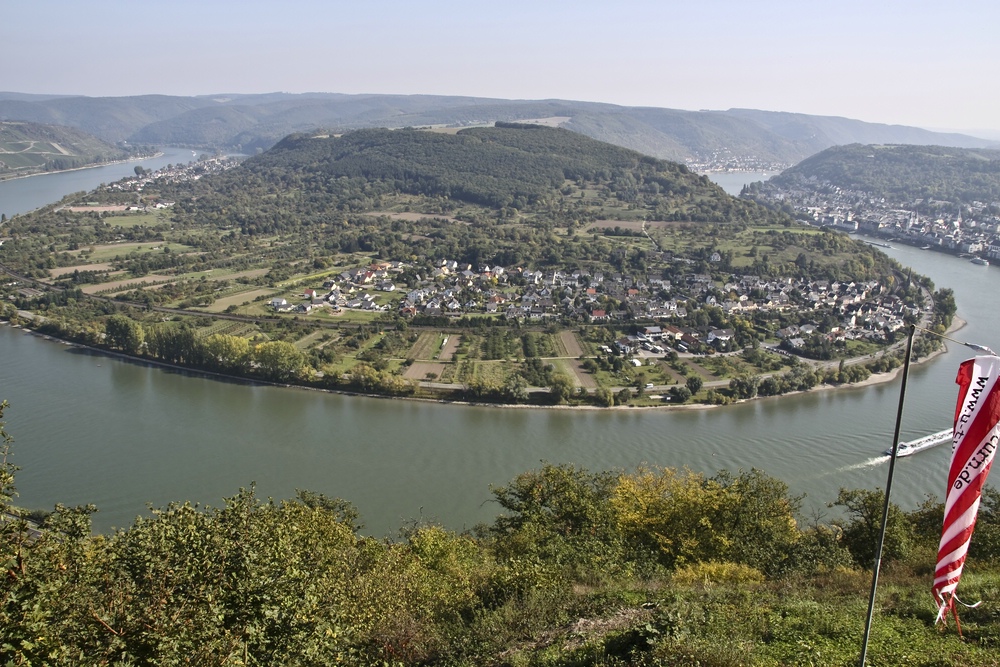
270, 252, 921, 355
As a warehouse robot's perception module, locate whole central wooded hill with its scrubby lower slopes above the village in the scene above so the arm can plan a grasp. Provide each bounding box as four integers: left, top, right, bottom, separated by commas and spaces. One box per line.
158, 124, 779, 241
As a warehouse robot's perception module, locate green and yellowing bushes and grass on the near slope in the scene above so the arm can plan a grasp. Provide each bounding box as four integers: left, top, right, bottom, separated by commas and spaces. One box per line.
0, 409, 1000, 666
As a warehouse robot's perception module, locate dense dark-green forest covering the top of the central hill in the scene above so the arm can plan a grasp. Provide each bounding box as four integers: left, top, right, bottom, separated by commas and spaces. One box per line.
262, 124, 712, 209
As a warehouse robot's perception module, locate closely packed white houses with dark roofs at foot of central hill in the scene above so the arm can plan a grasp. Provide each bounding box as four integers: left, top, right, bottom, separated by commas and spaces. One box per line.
271, 260, 917, 349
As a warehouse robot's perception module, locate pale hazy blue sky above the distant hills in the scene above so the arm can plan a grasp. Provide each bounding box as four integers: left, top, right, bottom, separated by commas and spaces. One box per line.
0, 0, 1000, 130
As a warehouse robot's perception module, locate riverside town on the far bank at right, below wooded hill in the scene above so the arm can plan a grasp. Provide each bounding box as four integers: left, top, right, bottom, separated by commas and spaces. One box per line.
756, 186, 1000, 260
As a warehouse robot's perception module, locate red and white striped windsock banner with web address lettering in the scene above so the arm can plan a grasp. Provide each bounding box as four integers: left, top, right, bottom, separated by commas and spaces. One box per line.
931, 356, 1000, 621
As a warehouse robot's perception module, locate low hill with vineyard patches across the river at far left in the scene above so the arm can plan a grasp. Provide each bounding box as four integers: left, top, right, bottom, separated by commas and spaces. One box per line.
0, 122, 143, 179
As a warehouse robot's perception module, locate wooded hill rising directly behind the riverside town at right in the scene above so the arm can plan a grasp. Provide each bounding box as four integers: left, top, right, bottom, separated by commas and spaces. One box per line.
769, 144, 1000, 203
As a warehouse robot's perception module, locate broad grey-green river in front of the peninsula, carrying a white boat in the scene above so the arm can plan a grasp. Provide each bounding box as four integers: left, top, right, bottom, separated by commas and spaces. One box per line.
0, 167, 1000, 536
